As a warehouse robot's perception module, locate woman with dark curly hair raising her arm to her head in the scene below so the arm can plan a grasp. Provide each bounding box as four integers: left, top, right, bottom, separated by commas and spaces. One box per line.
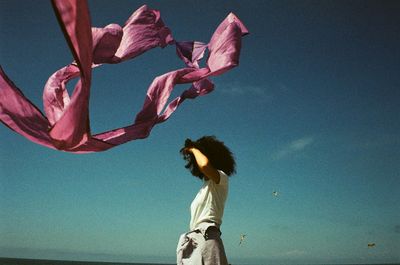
177, 136, 236, 265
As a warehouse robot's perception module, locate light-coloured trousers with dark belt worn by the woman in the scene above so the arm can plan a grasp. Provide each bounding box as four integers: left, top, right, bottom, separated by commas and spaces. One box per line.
176, 226, 228, 265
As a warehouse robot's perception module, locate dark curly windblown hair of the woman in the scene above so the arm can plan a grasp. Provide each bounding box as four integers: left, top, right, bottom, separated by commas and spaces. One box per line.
180, 136, 236, 179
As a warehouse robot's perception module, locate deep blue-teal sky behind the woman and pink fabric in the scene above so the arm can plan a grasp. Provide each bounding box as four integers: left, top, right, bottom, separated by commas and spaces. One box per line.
0, 0, 400, 264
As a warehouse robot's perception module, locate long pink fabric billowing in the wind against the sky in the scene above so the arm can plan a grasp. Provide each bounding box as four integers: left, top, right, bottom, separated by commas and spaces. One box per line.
0, 0, 248, 153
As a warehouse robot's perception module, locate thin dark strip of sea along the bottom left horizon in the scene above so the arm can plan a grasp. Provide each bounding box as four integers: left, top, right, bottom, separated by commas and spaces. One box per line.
0, 258, 173, 265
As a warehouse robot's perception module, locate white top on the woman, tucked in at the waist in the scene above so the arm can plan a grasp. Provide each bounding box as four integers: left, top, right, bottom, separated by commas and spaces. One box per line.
190, 170, 228, 230
